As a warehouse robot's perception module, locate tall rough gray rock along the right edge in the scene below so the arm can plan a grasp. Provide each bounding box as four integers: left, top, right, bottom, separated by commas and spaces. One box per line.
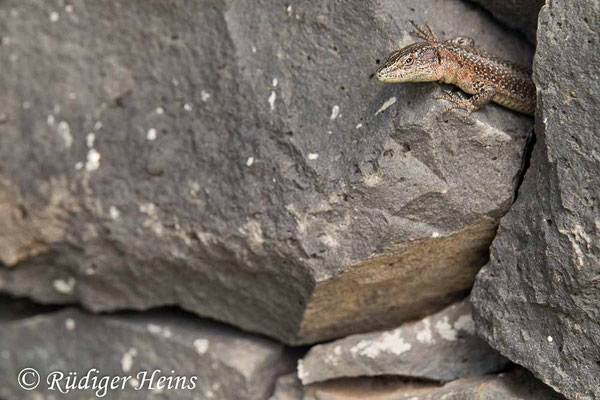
472, 1, 600, 400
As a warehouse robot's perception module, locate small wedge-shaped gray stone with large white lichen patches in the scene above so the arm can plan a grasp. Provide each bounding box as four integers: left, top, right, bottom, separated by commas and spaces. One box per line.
298, 300, 507, 384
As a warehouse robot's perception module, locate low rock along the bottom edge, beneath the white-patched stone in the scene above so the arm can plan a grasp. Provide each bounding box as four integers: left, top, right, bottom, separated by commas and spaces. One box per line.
271, 369, 564, 400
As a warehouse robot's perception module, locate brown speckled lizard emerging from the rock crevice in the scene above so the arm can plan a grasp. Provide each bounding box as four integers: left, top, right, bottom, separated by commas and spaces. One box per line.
376, 21, 535, 115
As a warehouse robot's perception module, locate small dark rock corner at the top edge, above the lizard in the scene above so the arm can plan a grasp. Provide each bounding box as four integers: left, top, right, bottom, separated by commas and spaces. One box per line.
472, 0, 546, 43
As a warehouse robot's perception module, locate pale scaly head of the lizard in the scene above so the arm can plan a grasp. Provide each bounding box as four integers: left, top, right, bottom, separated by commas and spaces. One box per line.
375, 42, 440, 83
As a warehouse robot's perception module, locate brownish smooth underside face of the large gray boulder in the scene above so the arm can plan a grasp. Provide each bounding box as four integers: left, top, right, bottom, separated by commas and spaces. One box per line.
299, 219, 496, 342
